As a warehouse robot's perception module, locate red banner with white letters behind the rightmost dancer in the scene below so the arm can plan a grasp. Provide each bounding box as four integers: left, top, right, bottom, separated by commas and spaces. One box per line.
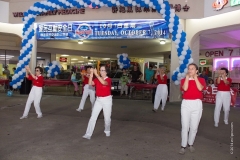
202, 86, 238, 107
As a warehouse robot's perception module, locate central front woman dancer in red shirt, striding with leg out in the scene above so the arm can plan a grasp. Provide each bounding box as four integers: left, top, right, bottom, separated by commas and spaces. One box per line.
83, 66, 112, 139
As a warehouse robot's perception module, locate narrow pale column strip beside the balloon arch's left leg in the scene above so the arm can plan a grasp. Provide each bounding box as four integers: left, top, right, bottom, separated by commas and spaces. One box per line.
29, 23, 37, 72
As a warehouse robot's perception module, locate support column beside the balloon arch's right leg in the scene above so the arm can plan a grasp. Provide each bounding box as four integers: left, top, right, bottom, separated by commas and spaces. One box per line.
169, 42, 181, 102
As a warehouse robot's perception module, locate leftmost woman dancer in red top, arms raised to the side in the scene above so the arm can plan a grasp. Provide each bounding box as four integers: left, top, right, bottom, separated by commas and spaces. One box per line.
20, 66, 43, 119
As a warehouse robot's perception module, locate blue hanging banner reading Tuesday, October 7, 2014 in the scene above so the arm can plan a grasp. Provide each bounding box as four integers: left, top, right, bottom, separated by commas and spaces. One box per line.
36, 20, 169, 40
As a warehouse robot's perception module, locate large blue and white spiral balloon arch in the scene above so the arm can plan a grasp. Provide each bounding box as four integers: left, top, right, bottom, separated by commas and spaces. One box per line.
11, 0, 193, 88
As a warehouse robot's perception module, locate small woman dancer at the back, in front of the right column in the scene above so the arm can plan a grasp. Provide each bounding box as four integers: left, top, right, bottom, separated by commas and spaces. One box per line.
153, 67, 168, 112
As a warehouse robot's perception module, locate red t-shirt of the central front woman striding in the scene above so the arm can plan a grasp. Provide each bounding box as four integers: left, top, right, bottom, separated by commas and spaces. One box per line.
93, 77, 112, 97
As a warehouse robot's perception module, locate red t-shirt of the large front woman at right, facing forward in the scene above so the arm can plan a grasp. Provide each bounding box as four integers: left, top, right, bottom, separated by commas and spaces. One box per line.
180, 77, 206, 100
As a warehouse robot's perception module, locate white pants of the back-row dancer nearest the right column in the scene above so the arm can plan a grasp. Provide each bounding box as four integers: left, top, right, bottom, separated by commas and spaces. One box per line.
154, 84, 168, 110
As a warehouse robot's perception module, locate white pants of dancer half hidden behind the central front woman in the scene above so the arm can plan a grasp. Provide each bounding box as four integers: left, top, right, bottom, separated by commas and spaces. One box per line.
78, 84, 95, 110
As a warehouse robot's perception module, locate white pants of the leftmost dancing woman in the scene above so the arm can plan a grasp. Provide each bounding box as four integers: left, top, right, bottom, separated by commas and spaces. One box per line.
23, 86, 42, 116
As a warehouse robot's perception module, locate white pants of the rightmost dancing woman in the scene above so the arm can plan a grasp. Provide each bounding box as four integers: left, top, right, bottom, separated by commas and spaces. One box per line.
214, 91, 231, 124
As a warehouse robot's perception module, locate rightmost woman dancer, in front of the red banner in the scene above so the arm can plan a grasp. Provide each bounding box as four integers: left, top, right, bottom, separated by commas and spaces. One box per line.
214, 68, 232, 127
